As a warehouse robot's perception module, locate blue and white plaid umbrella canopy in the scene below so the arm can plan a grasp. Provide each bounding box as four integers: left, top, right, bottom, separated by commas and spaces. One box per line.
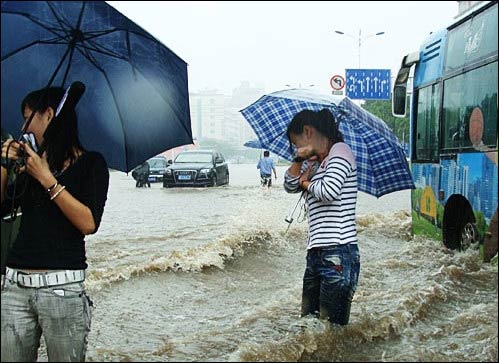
240, 89, 414, 197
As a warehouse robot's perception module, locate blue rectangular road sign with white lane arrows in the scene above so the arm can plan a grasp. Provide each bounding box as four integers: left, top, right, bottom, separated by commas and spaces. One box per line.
345, 69, 391, 100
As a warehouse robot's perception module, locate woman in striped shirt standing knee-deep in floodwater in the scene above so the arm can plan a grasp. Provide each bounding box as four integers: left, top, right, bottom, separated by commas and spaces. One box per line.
284, 109, 360, 325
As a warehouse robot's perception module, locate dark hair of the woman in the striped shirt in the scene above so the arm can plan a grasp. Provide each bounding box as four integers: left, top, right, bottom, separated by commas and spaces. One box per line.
286, 108, 343, 155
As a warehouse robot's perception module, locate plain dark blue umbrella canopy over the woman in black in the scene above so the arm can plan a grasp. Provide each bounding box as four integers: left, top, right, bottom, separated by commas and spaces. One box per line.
1, 1, 193, 172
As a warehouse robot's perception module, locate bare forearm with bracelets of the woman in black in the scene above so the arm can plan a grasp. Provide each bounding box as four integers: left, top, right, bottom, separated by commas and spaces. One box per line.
23, 143, 104, 235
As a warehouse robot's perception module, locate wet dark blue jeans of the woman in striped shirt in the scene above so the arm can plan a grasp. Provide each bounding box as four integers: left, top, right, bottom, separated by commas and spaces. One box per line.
301, 244, 360, 325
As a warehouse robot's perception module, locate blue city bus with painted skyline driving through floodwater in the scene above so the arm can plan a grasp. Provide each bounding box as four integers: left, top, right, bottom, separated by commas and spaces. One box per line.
392, 1, 498, 261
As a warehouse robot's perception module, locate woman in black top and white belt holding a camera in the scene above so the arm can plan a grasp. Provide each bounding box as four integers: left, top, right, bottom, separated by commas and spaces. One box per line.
1, 87, 109, 362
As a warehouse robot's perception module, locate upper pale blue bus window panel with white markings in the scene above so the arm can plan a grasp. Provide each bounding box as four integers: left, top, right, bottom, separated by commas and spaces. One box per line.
445, 4, 497, 73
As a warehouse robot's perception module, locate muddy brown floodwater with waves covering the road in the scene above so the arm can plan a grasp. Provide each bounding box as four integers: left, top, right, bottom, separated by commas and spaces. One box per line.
41, 165, 498, 362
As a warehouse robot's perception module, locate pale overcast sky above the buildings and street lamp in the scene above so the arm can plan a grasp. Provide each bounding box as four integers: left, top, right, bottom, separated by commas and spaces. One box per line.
108, 1, 458, 95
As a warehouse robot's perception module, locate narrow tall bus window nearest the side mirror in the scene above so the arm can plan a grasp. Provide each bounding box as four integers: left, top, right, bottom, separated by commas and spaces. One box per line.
414, 84, 440, 162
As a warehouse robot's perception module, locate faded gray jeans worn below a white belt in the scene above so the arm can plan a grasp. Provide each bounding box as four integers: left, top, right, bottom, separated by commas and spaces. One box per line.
1, 276, 91, 362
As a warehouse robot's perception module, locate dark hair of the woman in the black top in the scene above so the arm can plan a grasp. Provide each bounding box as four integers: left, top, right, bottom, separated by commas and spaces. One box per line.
21, 87, 85, 172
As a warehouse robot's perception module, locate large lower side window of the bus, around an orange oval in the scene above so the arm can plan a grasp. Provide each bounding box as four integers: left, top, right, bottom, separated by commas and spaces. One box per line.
442, 61, 497, 151
